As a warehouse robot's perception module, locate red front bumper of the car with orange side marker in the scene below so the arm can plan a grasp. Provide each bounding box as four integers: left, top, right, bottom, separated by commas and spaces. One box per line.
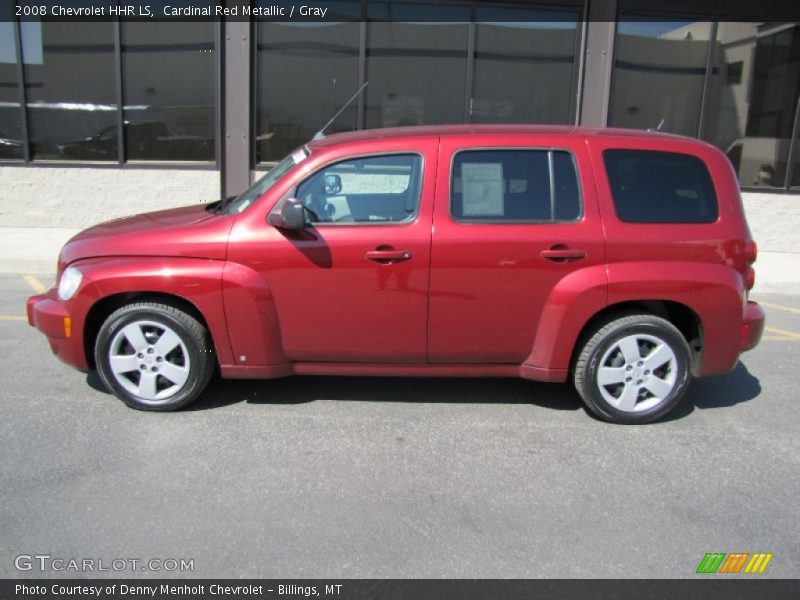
27, 289, 88, 370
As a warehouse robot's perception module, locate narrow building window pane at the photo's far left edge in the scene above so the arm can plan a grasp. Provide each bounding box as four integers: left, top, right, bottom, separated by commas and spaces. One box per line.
0, 19, 23, 160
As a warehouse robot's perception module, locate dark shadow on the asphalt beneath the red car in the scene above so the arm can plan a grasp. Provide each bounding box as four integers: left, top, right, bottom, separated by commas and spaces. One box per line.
86, 363, 761, 422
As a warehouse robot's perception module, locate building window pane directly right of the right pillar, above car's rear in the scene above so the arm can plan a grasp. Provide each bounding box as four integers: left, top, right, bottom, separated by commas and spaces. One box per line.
608, 19, 711, 136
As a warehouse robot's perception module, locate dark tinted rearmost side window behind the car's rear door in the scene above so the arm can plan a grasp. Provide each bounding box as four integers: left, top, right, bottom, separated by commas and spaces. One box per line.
603, 150, 718, 223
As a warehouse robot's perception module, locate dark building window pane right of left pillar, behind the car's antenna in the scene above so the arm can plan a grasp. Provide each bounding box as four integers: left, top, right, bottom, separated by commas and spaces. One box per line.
256, 2, 361, 162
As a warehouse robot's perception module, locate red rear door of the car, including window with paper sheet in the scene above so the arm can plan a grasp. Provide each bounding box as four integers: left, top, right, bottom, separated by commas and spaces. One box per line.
428, 136, 604, 364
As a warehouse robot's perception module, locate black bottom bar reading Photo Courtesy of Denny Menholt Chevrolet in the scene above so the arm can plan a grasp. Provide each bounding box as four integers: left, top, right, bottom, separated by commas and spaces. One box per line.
0, 576, 800, 600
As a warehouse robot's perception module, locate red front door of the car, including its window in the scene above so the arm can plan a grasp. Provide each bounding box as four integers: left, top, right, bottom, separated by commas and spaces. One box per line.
244, 148, 436, 363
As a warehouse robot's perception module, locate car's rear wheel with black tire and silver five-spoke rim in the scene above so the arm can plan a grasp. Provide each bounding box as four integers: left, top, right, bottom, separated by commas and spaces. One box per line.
573, 314, 691, 424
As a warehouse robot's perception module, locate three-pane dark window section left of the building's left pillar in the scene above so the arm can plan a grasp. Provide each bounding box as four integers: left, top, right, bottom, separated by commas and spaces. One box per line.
0, 17, 221, 164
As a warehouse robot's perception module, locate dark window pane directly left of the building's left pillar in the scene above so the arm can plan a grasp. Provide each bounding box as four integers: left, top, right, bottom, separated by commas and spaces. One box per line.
122, 21, 215, 161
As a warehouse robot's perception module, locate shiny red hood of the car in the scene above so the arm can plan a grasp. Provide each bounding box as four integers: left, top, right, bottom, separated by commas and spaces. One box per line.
58, 205, 233, 273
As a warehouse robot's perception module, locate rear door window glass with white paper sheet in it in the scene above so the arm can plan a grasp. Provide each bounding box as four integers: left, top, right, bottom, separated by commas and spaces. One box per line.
450, 150, 581, 223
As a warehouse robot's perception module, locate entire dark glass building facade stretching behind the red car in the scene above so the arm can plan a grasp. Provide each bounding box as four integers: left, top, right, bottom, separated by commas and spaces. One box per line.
0, 0, 800, 191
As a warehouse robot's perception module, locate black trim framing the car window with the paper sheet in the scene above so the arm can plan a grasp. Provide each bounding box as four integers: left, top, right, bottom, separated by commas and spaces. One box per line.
447, 146, 586, 225
